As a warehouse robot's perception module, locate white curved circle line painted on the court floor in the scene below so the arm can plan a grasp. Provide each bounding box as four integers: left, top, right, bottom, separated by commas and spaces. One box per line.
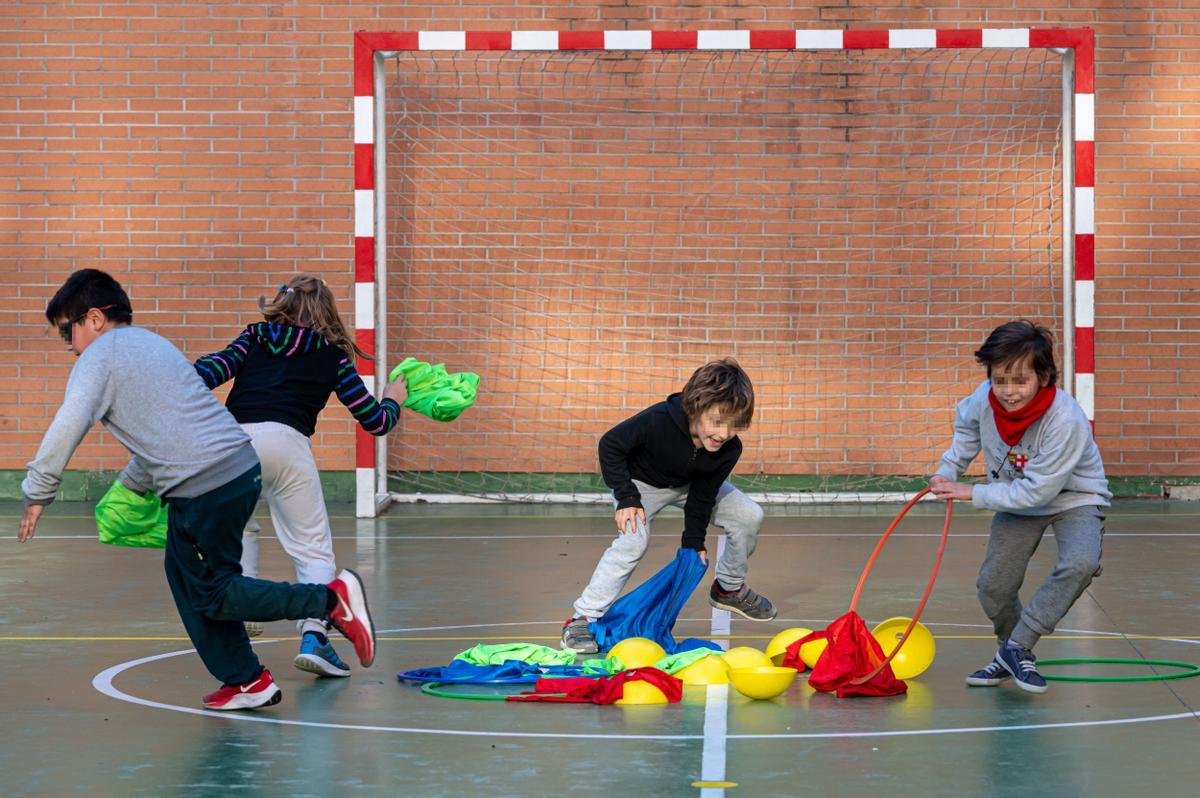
91, 620, 1200, 740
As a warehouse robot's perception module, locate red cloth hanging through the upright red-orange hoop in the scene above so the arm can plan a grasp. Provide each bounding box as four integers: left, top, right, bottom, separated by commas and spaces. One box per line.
782, 612, 908, 698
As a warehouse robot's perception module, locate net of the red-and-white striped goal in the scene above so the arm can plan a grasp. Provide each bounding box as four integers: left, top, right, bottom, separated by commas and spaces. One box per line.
380, 48, 1070, 502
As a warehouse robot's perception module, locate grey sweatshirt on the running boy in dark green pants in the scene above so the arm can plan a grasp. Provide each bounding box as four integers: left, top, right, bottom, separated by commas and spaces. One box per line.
20, 326, 258, 504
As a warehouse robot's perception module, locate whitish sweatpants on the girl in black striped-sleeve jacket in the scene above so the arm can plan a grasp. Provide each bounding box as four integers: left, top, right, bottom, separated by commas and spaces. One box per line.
241, 421, 337, 632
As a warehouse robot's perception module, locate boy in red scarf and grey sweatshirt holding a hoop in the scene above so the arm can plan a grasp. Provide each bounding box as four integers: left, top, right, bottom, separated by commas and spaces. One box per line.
929, 319, 1112, 692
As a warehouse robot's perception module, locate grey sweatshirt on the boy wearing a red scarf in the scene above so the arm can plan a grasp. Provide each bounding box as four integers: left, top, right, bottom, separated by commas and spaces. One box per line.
937, 380, 1112, 515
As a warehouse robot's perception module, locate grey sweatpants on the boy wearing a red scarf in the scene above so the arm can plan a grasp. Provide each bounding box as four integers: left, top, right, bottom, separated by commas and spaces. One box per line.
976, 506, 1104, 649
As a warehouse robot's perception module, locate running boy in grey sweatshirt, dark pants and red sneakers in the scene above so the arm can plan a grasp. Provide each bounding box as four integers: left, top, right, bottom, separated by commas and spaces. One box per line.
17, 269, 374, 709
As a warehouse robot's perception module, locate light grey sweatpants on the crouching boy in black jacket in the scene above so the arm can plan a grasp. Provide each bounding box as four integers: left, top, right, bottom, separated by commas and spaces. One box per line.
575, 480, 762, 619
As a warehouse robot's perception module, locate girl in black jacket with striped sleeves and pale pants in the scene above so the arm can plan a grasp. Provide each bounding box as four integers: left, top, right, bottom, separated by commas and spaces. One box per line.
196, 275, 403, 677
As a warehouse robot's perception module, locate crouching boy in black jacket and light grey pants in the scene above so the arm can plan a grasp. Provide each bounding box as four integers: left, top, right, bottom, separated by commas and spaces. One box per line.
563, 358, 775, 654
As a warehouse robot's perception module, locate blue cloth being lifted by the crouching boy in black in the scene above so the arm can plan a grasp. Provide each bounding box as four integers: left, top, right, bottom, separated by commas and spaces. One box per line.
588, 548, 721, 654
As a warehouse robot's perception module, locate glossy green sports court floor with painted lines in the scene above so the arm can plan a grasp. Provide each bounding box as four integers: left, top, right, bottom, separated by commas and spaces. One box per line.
0, 502, 1200, 798
